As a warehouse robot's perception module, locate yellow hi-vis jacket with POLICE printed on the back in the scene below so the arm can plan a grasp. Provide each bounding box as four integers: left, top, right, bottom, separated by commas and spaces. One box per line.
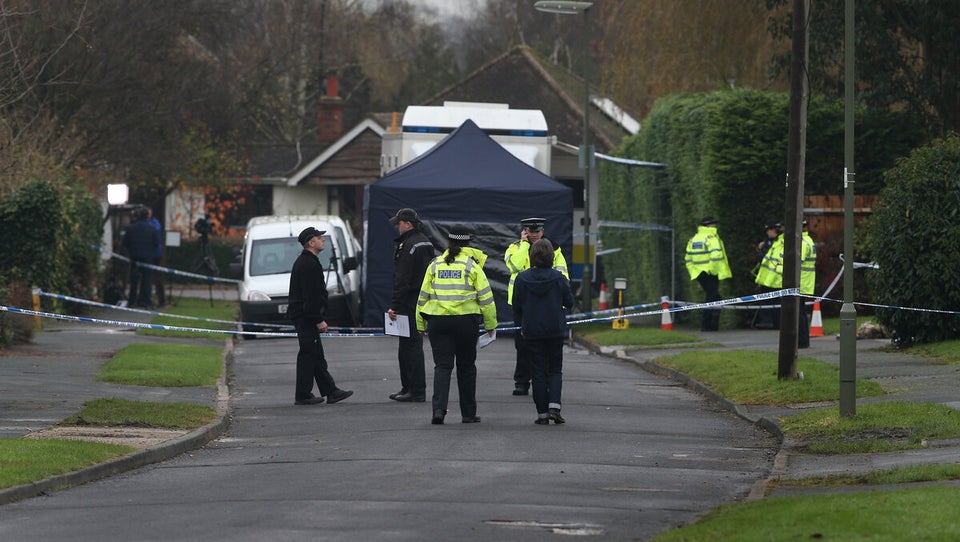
417, 247, 497, 331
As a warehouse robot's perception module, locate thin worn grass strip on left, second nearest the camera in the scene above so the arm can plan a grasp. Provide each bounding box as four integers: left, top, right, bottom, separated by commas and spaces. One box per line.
60, 398, 216, 429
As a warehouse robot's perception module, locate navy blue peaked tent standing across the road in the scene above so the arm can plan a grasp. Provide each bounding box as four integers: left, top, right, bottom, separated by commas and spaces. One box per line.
363, 119, 573, 326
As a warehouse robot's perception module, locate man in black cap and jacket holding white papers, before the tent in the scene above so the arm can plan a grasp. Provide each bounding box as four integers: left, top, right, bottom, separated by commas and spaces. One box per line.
387, 208, 435, 403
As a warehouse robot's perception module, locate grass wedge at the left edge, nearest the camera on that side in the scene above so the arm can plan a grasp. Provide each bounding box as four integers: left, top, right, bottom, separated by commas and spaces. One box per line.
0, 439, 135, 489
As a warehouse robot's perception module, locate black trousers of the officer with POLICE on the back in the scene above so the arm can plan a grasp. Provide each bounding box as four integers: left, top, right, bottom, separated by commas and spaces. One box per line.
427, 314, 480, 417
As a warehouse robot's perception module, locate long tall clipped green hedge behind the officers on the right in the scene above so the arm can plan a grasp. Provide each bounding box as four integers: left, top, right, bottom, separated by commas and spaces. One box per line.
600, 89, 923, 320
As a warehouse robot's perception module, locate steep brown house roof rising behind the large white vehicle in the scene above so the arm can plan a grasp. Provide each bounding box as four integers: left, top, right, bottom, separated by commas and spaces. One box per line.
424, 46, 631, 152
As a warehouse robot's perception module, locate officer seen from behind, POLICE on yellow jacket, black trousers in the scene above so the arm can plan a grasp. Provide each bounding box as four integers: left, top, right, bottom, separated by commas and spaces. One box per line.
417, 227, 497, 424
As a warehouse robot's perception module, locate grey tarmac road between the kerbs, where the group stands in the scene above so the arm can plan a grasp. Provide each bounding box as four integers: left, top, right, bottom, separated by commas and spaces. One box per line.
0, 330, 776, 541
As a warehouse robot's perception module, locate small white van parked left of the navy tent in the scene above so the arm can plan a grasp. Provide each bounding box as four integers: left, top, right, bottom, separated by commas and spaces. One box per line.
230, 215, 363, 331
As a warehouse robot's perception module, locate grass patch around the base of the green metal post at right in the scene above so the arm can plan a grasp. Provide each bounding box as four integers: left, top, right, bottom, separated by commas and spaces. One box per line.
780, 402, 960, 454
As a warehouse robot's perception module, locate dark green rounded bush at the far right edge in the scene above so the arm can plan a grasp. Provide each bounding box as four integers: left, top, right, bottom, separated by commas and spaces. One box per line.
865, 134, 960, 346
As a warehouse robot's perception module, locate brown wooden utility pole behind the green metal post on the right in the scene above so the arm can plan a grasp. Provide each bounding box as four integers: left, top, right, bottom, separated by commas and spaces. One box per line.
777, 0, 810, 379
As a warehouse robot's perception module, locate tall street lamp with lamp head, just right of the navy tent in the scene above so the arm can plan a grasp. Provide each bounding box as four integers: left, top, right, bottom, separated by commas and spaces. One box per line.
533, 0, 594, 311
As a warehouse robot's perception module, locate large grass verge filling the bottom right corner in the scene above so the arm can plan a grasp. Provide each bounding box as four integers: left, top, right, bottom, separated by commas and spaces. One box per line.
652, 486, 960, 542
